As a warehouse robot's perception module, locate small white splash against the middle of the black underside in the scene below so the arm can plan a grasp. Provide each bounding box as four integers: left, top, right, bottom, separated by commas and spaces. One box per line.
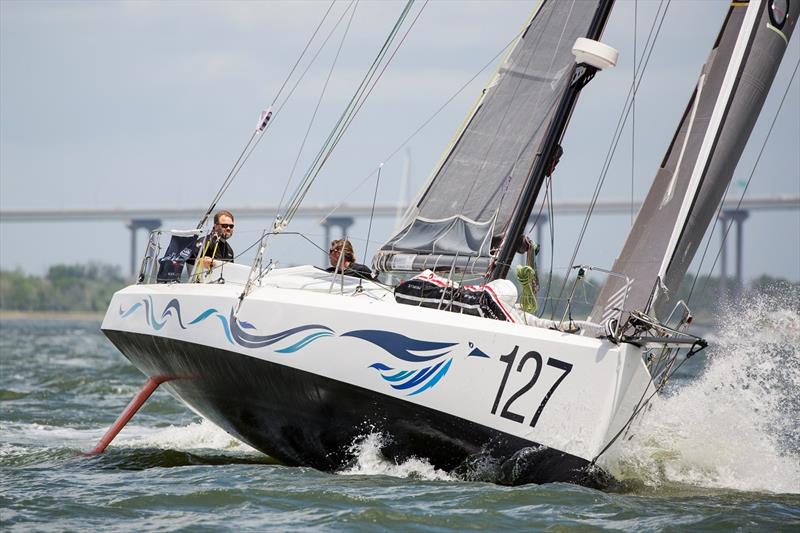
337, 432, 454, 481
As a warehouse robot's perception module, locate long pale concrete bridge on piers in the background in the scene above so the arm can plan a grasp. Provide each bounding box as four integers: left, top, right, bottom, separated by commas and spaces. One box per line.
0, 196, 800, 286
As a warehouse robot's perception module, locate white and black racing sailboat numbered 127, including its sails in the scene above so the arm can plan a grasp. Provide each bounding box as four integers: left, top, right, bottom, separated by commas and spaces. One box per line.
95, 0, 800, 485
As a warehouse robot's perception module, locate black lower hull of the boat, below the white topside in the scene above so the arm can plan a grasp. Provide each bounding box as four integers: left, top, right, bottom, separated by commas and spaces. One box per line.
104, 330, 606, 486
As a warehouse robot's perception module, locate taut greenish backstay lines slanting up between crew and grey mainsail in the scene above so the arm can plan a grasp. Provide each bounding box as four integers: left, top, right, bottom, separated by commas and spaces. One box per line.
275, 0, 424, 229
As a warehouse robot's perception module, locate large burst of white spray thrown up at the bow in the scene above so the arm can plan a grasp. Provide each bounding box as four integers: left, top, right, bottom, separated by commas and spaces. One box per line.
604, 293, 800, 493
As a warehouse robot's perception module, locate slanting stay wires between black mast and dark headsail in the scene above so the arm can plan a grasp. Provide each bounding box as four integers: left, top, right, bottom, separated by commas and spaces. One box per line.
545, 0, 671, 318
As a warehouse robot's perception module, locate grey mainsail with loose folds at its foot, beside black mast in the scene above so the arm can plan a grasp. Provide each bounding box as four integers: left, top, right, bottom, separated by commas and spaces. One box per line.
373, 0, 601, 273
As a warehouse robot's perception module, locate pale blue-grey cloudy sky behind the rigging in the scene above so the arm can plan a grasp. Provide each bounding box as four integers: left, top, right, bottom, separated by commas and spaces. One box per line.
0, 0, 800, 281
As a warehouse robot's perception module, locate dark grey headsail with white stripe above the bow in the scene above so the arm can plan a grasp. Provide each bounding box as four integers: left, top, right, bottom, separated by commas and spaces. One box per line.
589, 0, 800, 323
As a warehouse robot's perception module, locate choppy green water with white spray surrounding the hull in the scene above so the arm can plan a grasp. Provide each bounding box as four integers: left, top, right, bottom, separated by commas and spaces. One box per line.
0, 312, 800, 531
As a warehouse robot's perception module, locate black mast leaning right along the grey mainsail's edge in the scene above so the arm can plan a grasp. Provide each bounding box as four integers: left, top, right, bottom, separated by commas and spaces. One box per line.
490, 0, 614, 279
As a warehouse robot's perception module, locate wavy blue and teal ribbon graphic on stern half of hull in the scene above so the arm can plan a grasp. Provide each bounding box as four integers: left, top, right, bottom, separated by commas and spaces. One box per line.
119, 296, 334, 353
